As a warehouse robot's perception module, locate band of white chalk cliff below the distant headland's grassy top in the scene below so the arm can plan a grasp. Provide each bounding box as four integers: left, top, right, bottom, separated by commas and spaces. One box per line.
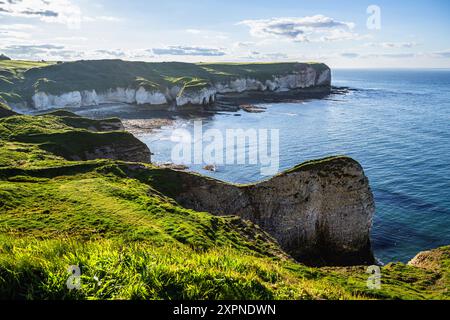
32, 67, 331, 110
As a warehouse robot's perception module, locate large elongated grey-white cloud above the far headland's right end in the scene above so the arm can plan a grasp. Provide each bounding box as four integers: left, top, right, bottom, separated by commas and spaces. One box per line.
238, 15, 359, 42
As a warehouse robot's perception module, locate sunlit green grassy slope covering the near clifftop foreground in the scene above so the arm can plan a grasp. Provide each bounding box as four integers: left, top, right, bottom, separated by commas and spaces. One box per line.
0, 115, 450, 299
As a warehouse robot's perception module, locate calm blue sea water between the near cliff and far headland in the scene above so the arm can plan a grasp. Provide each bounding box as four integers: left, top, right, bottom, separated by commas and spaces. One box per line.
140, 70, 450, 262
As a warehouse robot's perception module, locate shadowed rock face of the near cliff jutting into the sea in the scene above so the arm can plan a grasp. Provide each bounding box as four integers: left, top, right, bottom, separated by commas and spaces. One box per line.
156, 157, 375, 265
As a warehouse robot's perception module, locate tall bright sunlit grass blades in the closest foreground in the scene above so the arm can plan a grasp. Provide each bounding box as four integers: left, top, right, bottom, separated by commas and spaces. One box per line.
0, 238, 326, 300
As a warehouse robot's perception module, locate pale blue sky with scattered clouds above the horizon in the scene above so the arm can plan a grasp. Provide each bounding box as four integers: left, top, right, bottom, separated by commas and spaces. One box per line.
0, 0, 450, 68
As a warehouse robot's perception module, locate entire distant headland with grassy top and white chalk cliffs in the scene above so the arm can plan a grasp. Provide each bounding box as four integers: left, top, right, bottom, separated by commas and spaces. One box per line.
0, 60, 331, 112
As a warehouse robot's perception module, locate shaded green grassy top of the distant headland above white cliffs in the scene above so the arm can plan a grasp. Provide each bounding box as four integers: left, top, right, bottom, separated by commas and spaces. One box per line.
0, 60, 327, 102
